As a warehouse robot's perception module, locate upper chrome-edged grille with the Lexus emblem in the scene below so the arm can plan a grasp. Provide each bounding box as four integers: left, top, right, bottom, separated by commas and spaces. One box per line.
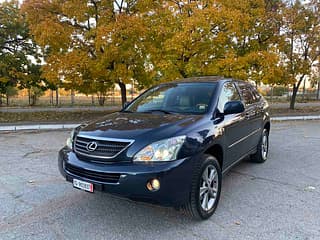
74, 136, 132, 159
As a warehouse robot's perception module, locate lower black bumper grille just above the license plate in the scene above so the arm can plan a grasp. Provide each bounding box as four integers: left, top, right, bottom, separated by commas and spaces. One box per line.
65, 164, 120, 183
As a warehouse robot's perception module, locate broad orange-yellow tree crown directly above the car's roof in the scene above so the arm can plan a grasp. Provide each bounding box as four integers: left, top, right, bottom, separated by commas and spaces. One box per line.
146, 0, 283, 88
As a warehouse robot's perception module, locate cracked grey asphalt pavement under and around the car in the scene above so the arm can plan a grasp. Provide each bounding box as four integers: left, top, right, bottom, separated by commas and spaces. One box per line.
0, 121, 320, 240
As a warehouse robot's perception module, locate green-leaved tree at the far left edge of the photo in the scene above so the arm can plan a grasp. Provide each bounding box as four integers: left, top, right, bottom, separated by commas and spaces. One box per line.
0, 1, 39, 105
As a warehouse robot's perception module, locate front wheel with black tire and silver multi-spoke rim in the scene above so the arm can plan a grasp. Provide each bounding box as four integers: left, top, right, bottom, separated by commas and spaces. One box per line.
182, 154, 222, 220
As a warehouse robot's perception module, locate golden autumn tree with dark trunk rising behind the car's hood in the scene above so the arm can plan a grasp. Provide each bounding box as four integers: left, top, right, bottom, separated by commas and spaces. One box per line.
97, 1, 156, 103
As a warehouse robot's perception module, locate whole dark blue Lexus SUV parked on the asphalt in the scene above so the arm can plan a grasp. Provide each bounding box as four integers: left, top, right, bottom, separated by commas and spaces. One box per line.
59, 77, 270, 219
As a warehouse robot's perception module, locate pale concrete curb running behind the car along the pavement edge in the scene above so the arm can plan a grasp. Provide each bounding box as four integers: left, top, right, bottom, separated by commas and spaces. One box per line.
0, 115, 320, 132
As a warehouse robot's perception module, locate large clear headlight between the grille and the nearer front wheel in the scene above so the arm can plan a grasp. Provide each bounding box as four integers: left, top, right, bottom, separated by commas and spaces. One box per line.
133, 136, 186, 162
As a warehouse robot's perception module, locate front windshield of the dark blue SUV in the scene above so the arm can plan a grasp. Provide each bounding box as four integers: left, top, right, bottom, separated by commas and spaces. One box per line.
124, 83, 216, 114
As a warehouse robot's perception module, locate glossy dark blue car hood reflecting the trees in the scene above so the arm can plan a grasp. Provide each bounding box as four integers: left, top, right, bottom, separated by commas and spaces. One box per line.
80, 112, 202, 140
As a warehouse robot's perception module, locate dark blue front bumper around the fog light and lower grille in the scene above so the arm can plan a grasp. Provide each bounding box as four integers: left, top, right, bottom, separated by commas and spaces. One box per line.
58, 147, 196, 206
